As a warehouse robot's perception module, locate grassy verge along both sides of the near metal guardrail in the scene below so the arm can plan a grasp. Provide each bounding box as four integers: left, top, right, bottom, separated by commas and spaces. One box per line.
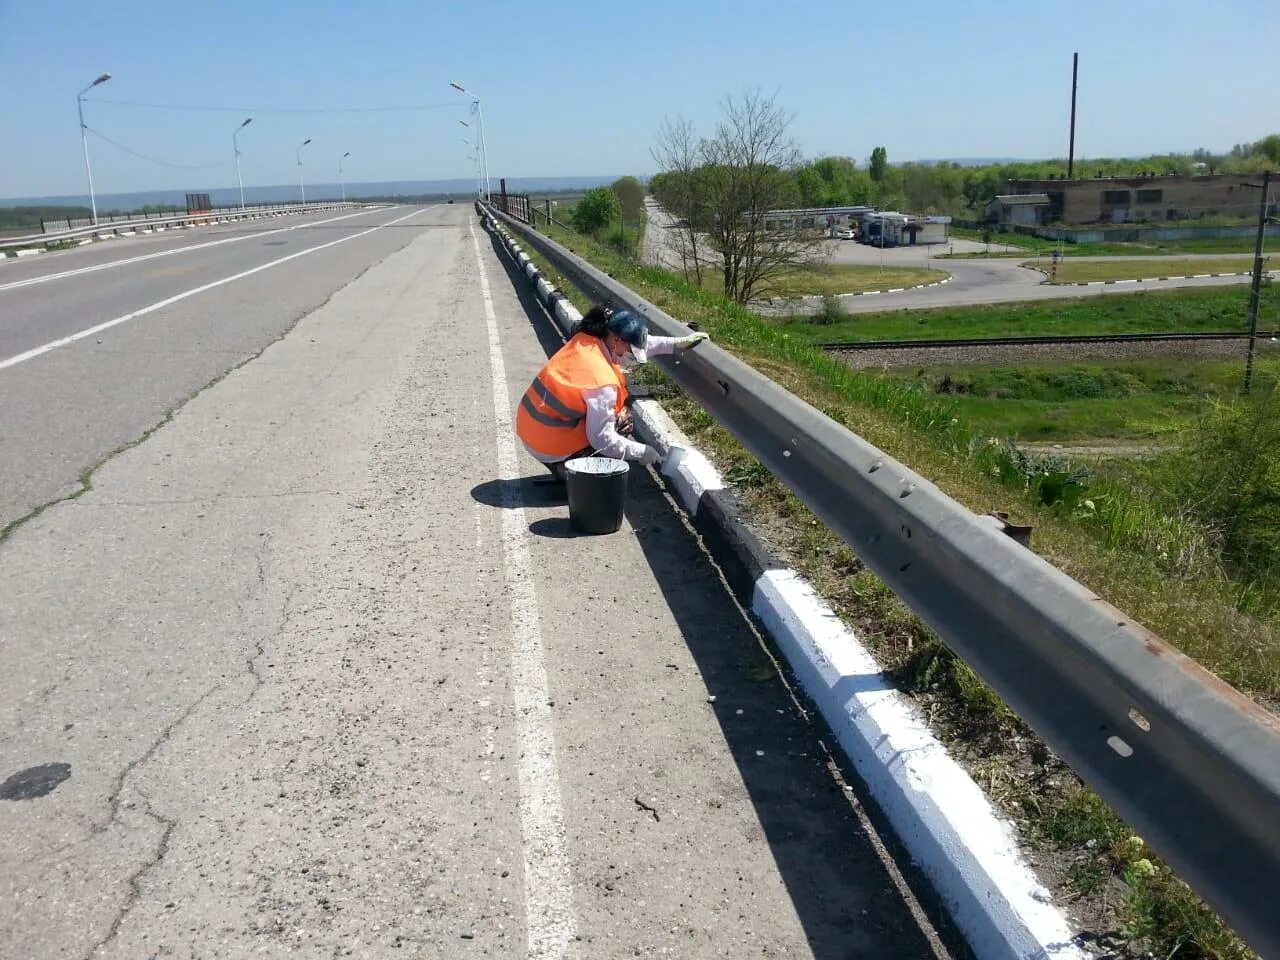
514, 216, 1264, 960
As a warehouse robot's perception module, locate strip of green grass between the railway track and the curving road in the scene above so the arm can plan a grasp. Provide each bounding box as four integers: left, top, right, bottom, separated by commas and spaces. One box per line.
783, 287, 1280, 343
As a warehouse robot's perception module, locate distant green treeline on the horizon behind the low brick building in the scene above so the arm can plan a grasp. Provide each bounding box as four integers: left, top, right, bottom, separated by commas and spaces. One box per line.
649, 133, 1280, 219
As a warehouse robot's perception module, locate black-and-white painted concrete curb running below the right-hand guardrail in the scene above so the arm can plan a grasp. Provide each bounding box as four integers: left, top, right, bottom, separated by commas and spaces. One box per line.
485, 209, 1089, 960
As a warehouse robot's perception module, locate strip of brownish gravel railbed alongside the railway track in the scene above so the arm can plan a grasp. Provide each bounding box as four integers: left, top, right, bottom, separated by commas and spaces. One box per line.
831, 338, 1280, 370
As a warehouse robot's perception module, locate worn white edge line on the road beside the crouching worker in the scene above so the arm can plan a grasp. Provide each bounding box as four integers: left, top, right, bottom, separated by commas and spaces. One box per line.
468, 224, 575, 960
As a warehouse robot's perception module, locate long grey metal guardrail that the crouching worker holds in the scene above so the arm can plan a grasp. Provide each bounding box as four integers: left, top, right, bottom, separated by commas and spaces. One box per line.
481, 200, 1280, 956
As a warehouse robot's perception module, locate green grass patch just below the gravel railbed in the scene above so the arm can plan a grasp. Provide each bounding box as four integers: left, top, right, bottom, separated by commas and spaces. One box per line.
881, 358, 1272, 442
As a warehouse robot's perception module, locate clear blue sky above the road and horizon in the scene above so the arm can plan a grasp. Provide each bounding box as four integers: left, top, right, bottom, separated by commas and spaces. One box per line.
0, 0, 1280, 197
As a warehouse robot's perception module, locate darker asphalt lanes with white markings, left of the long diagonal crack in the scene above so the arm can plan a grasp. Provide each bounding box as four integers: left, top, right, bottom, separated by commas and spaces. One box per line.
0, 207, 445, 530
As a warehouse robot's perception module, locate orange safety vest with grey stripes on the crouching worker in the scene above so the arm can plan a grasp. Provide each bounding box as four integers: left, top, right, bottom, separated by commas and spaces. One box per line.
516, 333, 627, 457
